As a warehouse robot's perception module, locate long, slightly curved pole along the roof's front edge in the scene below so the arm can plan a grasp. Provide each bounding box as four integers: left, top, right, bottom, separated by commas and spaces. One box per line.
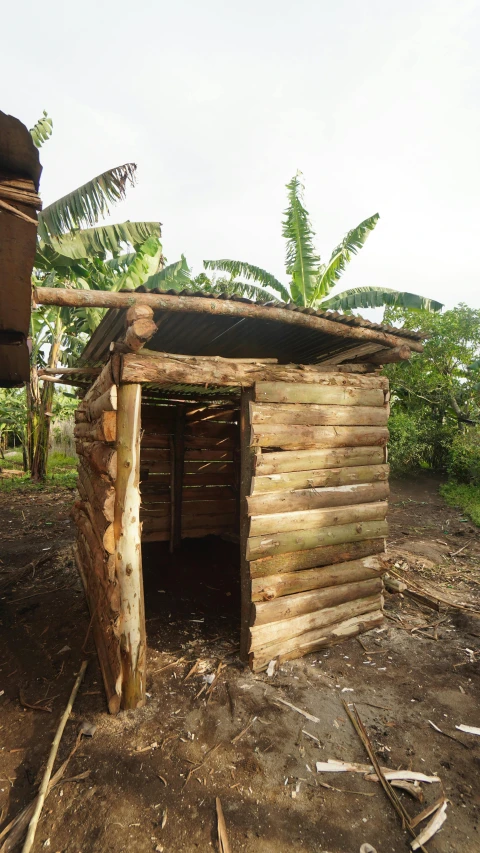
34, 287, 423, 352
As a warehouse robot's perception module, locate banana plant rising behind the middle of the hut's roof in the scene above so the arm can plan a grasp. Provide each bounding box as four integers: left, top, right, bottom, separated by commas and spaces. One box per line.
203, 173, 443, 312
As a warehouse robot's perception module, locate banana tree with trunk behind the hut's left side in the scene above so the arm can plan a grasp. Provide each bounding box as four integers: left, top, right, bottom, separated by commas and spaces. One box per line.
27, 113, 163, 480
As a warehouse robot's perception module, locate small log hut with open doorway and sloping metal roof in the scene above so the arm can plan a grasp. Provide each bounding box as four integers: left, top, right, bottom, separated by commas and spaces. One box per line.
36, 288, 422, 712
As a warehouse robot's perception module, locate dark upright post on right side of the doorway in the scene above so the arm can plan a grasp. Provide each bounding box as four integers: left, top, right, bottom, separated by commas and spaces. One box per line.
240, 388, 255, 663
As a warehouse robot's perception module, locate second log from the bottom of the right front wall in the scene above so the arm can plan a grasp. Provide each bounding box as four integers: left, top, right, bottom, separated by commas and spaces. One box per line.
249, 594, 382, 651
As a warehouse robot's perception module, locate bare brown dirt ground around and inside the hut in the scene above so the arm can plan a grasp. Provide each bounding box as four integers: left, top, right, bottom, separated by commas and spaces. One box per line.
0, 477, 480, 853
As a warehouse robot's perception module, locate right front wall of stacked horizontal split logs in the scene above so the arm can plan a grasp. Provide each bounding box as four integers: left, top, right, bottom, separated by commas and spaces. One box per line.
241, 372, 389, 671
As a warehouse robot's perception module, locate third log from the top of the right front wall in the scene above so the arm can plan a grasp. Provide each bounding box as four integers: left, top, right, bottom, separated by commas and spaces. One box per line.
250, 424, 389, 450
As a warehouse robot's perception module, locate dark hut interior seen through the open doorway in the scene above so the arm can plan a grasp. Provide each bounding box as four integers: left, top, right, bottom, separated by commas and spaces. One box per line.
140, 396, 244, 651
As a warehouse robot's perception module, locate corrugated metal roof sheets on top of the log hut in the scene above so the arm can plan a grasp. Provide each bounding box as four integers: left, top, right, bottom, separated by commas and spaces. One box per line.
81, 287, 422, 364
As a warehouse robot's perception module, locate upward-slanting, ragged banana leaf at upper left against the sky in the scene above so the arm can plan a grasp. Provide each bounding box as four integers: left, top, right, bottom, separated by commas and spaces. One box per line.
38, 163, 137, 242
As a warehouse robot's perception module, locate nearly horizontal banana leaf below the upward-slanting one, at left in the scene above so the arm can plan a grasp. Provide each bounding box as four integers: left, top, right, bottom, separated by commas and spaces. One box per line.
39, 222, 161, 260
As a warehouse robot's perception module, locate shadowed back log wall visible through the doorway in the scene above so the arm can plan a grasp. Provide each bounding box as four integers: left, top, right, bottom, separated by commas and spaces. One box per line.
140, 403, 240, 547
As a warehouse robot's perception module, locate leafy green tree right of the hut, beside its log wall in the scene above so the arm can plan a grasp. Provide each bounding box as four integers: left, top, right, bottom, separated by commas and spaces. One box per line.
384, 305, 480, 472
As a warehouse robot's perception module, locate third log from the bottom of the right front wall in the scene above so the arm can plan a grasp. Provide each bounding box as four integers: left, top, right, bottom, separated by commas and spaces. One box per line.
252, 577, 383, 626
